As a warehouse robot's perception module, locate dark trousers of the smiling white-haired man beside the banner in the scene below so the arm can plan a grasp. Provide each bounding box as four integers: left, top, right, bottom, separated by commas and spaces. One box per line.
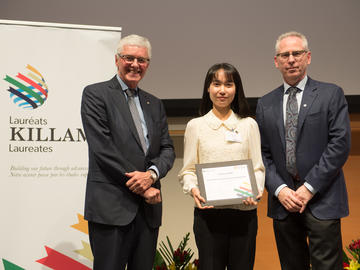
89, 207, 159, 270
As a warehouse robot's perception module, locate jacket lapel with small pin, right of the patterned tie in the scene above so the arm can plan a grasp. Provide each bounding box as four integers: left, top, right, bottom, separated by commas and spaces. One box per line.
296, 77, 317, 138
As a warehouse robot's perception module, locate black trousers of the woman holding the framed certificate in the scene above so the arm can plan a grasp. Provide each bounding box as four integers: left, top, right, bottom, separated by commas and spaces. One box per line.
194, 208, 257, 270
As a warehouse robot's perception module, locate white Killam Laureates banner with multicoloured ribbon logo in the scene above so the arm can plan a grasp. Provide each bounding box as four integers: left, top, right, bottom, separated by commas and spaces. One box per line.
0, 21, 121, 270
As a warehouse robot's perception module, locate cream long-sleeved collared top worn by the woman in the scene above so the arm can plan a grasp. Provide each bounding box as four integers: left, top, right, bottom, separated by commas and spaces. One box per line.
179, 111, 265, 210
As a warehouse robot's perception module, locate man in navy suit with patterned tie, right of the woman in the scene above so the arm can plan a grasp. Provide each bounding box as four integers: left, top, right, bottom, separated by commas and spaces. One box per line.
256, 32, 350, 270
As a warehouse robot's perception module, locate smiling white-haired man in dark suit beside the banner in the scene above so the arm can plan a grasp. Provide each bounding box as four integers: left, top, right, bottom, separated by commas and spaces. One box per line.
81, 35, 175, 270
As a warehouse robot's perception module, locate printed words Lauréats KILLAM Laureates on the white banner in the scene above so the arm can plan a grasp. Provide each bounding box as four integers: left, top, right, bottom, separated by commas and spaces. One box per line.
9, 116, 86, 152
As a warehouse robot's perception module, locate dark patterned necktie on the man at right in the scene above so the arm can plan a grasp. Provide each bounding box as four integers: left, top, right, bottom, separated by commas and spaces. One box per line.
285, 87, 300, 176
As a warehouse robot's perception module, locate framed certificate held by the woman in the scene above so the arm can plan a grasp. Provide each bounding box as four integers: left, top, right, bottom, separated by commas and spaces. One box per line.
195, 159, 259, 206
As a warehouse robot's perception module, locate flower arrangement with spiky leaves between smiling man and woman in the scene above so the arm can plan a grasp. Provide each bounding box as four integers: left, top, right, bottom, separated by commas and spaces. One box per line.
153, 233, 199, 270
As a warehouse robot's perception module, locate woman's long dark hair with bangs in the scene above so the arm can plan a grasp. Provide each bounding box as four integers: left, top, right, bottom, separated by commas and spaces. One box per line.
199, 63, 250, 117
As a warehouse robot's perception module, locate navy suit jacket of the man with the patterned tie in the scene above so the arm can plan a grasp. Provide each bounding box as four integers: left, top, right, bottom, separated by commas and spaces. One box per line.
256, 78, 350, 219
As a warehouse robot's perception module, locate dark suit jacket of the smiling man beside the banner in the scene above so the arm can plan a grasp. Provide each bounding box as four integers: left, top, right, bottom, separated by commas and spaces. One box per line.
81, 76, 175, 228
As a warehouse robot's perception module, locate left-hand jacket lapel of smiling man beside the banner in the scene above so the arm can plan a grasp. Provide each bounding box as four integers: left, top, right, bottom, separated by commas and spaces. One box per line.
110, 76, 142, 149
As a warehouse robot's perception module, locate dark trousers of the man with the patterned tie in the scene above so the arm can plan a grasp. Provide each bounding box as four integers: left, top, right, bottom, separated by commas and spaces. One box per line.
273, 209, 343, 270
